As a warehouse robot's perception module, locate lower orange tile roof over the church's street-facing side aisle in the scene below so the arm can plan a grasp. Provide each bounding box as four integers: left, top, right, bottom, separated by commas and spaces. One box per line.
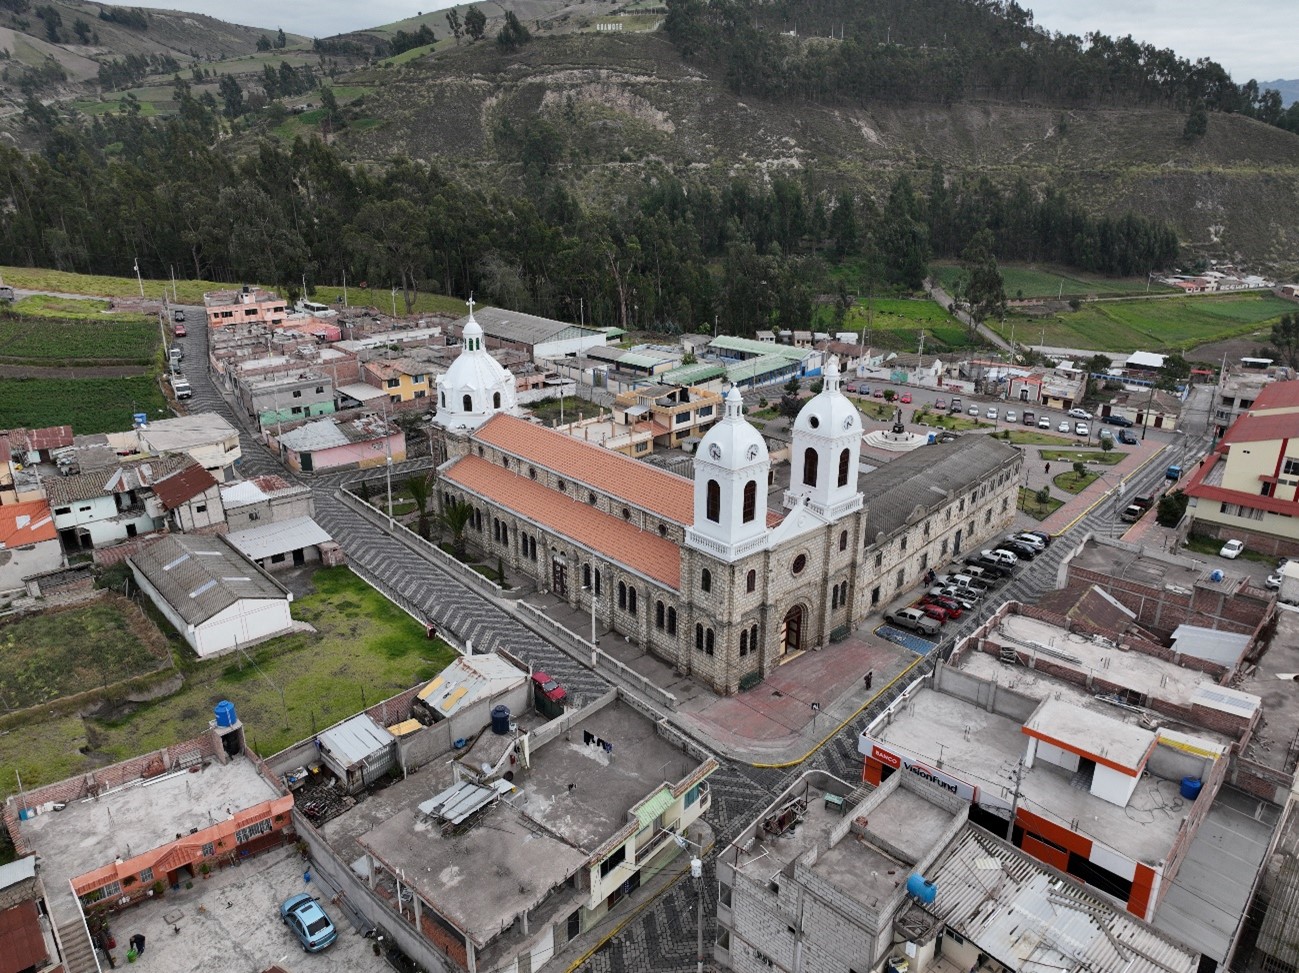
446, 454, 681, 588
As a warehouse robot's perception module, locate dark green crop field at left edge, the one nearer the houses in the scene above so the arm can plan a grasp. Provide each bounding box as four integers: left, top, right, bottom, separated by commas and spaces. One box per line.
0, 375, 171, 435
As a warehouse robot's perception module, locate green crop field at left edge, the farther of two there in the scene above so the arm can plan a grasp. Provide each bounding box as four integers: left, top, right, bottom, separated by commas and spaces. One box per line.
0, 311, 161, 368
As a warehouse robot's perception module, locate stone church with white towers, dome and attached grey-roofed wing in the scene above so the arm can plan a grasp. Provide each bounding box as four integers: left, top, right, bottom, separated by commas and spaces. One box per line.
435, 307, 1021, 695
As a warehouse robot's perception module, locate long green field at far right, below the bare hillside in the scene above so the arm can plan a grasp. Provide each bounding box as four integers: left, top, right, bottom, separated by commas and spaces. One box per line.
996, 294, 1294, 352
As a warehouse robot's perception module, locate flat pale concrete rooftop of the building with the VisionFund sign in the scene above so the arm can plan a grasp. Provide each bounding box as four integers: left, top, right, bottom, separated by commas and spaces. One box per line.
877, 689, 1189, 861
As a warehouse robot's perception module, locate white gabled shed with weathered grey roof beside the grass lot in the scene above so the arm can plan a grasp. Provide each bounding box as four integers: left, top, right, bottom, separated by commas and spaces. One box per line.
127, 534, 294, 659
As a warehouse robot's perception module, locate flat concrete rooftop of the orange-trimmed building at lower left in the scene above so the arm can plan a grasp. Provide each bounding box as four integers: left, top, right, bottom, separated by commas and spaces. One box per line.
18, 757, 279, 924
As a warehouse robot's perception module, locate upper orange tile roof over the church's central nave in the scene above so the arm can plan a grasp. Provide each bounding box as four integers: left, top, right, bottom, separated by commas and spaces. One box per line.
474, 414, 695, 525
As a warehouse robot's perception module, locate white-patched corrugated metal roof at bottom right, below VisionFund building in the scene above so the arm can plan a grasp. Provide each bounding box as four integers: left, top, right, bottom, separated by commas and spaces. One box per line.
924, 825, 1199, 973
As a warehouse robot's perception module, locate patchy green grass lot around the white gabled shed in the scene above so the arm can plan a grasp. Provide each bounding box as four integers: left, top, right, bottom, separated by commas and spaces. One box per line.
0, 568, 455, 798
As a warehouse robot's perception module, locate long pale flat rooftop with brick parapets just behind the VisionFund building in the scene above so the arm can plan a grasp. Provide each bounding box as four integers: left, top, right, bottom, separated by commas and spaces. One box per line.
976, 614, 1212, 707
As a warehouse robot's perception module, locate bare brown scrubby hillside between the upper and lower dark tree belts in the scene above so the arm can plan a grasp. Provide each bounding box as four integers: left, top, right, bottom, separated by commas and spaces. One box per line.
338, 31, 1299, 269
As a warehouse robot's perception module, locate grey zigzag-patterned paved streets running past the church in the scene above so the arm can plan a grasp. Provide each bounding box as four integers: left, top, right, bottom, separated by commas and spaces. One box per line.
186, 315, 1215, 973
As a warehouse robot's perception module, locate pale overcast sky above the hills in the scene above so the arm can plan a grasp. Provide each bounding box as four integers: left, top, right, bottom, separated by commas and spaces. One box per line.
126, 0, 1299, 83
